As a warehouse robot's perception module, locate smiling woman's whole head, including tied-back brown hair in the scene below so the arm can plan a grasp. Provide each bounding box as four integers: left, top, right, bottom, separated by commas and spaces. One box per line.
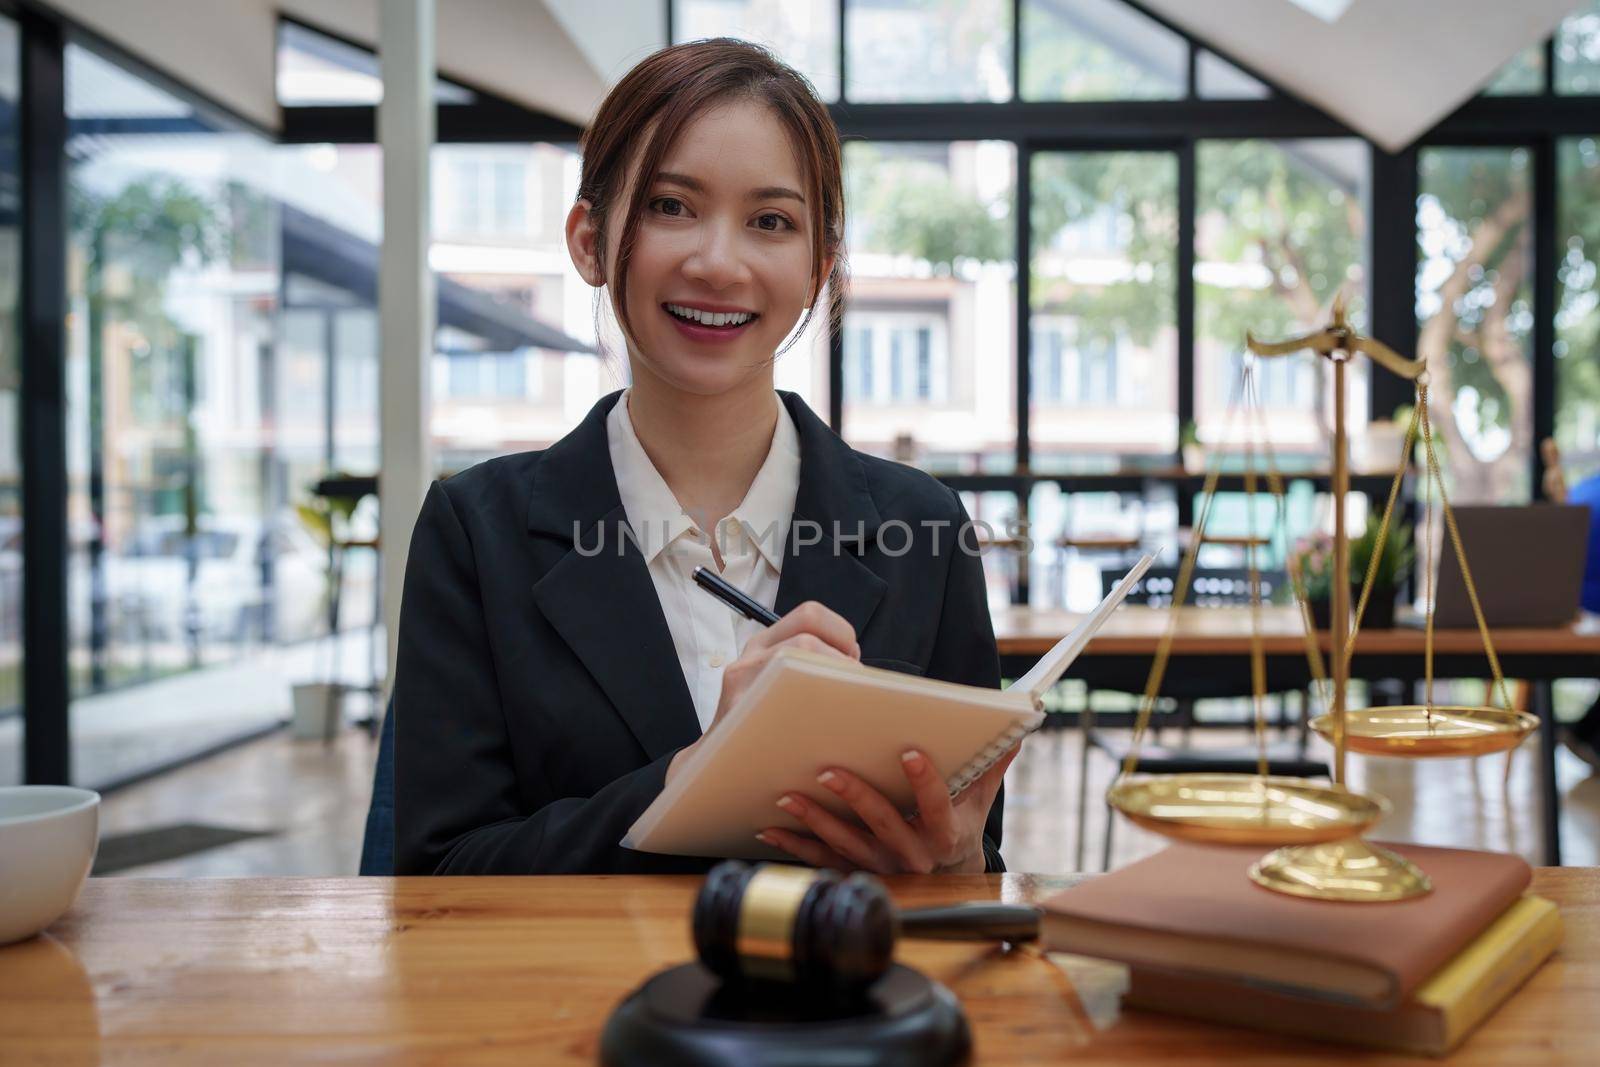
568, 40, 845, 399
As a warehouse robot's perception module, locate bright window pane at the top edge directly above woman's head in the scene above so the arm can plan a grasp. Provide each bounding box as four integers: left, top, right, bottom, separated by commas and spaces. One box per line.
672, 0, 840, 101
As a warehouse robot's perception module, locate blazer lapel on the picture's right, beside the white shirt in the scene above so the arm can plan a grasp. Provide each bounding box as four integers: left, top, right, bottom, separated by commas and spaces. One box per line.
773, 392, 888, 637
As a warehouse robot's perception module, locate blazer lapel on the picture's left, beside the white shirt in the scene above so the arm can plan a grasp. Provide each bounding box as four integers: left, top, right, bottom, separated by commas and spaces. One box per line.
528, 394, 701, 760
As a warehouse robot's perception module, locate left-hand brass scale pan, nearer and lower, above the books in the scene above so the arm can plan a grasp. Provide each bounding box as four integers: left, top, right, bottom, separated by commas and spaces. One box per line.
1106, 774, 1389, 846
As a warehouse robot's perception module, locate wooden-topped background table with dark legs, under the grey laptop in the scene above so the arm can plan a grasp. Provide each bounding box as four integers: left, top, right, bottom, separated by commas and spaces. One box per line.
992, 605, 1600, 865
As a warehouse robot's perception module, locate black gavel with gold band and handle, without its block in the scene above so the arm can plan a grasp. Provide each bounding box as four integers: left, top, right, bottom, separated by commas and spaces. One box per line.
694, 859, 1038, 995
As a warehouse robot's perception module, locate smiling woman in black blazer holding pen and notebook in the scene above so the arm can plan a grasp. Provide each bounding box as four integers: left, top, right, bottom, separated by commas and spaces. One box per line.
394, 38, 1010, 873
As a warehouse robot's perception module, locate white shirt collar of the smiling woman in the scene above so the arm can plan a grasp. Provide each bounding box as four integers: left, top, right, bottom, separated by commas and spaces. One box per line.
606, 390, 800, 571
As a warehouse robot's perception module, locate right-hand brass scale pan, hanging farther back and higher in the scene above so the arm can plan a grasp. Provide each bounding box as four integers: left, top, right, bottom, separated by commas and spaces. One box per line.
1310, 704, 1539, 757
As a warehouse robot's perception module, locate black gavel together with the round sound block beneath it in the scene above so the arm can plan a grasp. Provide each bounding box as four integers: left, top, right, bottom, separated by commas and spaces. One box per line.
600, 861, 1038, 1067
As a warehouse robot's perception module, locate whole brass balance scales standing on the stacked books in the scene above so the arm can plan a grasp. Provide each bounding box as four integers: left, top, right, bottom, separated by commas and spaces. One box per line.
1106, 294, 1539, 902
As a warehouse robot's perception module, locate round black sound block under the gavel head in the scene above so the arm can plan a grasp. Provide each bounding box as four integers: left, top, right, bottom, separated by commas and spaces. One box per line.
600, 963, 971, 1067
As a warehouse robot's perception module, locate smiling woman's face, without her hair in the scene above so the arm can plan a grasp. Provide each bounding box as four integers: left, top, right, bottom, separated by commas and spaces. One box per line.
574, 101, 826, 395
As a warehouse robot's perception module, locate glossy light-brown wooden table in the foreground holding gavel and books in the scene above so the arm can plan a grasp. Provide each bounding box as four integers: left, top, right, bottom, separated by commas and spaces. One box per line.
0, 869, 1600, 1067
